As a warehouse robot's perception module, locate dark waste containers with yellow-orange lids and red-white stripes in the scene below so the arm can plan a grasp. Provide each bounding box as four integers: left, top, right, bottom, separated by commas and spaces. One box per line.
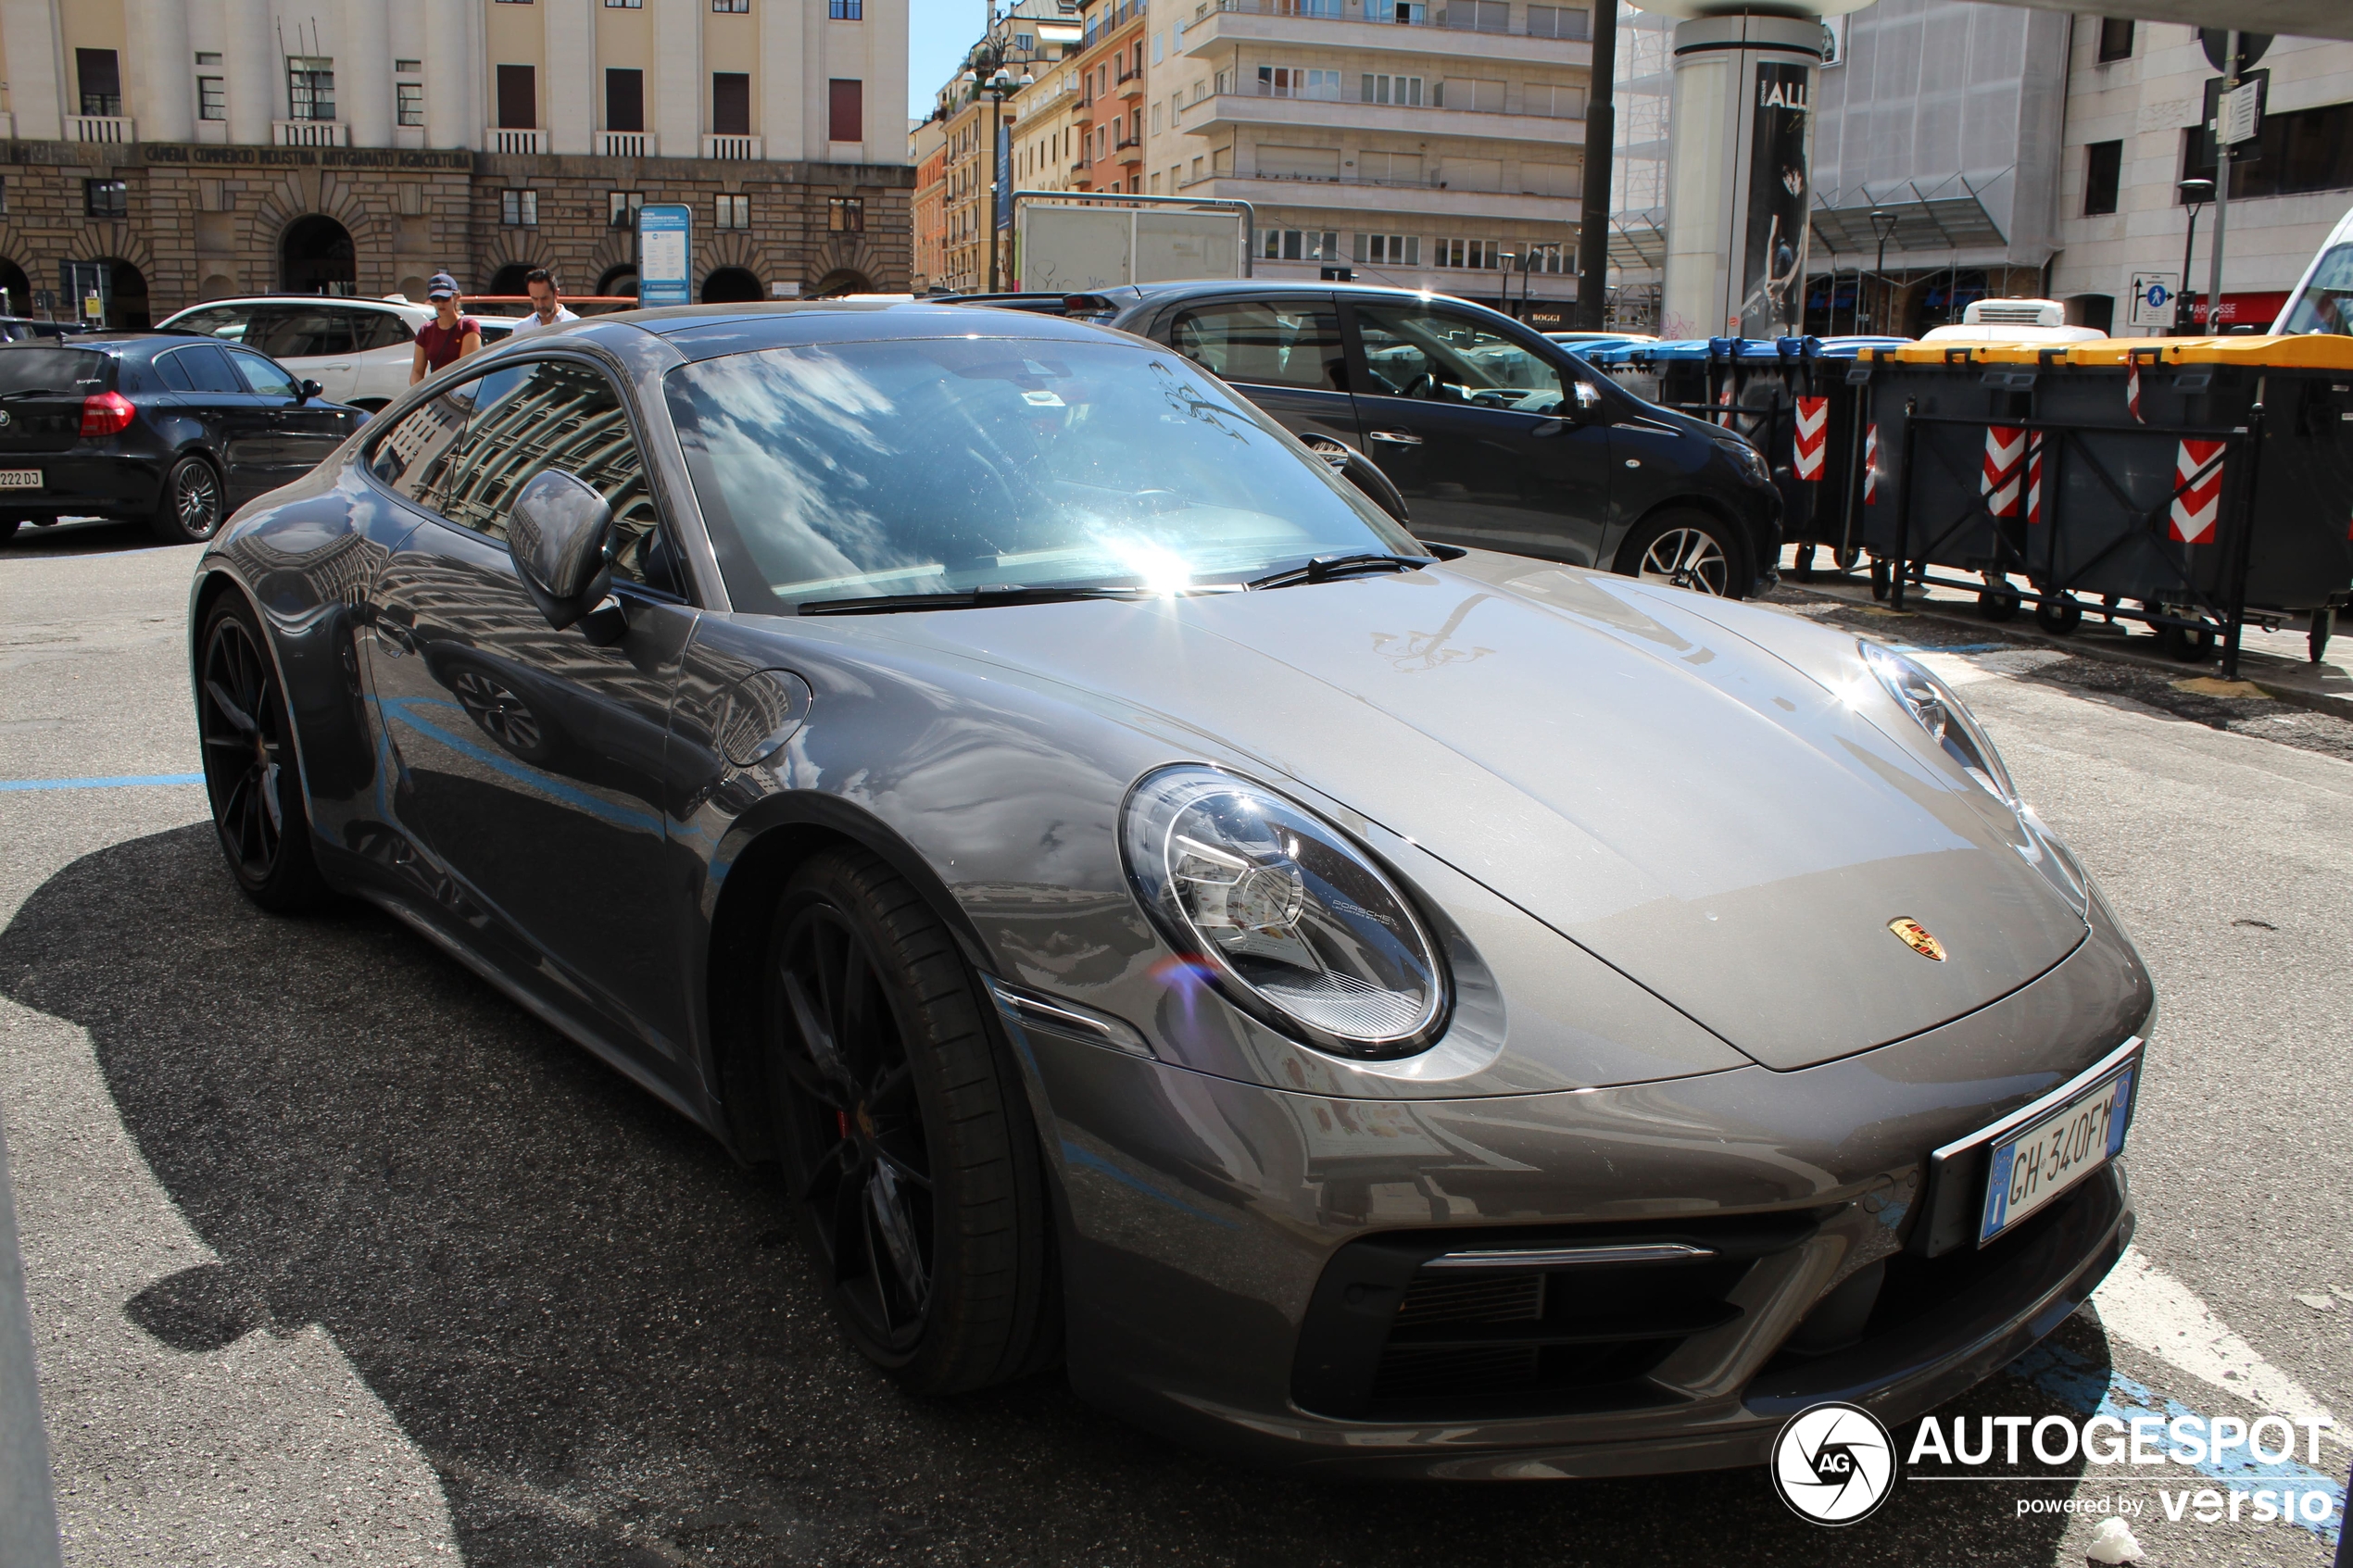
1864, 336, 2353, 674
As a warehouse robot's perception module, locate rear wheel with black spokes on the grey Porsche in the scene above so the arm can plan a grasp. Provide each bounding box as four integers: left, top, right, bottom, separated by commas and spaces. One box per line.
195, 595, 325, 909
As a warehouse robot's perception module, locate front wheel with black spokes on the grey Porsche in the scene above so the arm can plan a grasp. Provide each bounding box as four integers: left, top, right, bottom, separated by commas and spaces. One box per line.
765, 848, 1059, 1394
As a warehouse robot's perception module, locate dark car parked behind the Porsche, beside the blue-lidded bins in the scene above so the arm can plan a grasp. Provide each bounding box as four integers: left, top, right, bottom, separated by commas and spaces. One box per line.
958, 280, 1781, 597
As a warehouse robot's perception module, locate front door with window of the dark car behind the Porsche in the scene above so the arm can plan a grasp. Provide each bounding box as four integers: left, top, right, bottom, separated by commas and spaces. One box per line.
1351, 303, 1609, 567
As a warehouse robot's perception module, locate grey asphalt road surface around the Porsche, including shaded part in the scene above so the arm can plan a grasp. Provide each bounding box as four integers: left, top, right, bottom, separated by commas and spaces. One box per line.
0, 527, 2353, 1568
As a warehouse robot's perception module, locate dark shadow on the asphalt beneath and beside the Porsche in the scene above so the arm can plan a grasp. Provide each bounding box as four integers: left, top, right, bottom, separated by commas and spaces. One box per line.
0, 825, 2106, 1568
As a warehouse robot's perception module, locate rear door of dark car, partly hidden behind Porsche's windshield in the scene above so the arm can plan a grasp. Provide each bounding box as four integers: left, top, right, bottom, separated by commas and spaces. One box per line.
1167, 296, 1365, 451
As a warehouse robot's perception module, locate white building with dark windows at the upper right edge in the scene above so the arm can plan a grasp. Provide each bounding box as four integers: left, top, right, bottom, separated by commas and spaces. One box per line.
2052, 14, 2353, 336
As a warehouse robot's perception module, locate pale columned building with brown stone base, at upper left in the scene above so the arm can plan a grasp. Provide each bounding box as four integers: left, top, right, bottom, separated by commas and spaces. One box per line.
0, 0, 913, 327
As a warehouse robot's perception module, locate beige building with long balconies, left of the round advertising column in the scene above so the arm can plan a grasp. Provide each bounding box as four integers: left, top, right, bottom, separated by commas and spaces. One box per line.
1148, 0, 1593, 320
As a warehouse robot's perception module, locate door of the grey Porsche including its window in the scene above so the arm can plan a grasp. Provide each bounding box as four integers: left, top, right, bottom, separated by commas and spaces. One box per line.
353, 362, 694, 1067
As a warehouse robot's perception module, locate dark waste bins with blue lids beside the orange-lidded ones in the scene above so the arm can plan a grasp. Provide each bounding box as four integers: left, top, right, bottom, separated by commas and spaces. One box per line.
1589, 339, 1908, 576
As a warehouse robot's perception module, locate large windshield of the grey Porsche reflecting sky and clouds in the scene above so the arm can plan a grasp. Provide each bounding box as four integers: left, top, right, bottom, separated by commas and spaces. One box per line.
668, 339, 1419, 613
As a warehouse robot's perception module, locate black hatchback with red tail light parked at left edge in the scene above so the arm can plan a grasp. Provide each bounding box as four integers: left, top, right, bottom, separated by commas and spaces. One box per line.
0, 332, 367, 543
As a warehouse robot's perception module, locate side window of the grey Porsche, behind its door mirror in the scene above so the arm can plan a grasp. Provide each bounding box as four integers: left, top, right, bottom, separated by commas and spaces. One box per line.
376, 359, 675, 590
